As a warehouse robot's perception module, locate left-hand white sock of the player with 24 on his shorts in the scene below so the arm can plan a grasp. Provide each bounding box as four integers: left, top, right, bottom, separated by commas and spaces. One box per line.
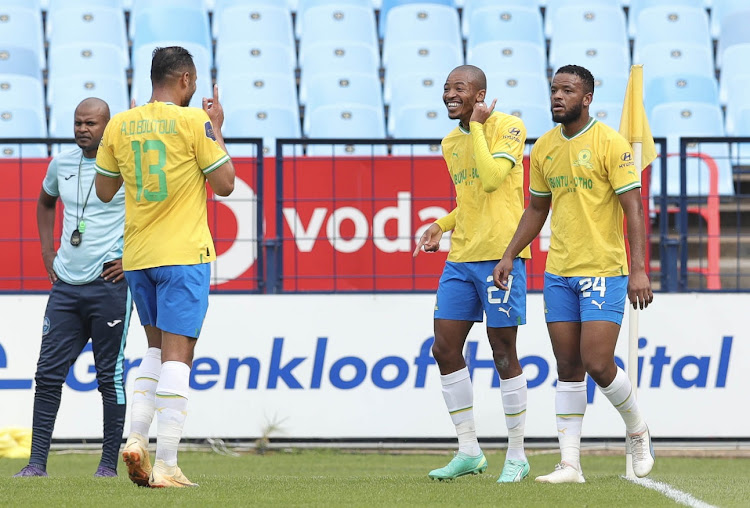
555, 381, 587, 471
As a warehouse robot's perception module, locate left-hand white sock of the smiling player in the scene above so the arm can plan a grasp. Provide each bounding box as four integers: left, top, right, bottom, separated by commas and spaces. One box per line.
440, 367, 482, 457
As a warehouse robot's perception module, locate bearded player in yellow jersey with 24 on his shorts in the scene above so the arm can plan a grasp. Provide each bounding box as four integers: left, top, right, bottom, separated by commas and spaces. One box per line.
493, 65, 654, 483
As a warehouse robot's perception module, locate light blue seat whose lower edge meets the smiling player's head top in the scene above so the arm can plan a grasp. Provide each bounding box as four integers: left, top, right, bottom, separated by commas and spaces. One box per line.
466, 40, 547, 75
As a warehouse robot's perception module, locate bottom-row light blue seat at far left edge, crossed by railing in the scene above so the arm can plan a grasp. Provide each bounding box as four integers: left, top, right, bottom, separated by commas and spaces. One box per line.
0, 108, 47, 158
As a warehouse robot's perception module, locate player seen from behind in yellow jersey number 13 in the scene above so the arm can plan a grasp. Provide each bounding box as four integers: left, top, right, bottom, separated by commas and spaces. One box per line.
96, 46, 235, 487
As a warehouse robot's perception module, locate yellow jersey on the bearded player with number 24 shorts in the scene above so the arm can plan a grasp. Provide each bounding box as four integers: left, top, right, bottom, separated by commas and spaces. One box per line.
529, 118, 641, 277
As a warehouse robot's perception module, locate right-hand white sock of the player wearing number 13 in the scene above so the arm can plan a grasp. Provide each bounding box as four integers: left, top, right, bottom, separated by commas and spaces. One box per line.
156, 361, 190, 466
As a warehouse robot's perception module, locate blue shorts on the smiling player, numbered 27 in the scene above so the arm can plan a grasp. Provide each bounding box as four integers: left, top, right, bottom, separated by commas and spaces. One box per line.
435, 258, 526, 328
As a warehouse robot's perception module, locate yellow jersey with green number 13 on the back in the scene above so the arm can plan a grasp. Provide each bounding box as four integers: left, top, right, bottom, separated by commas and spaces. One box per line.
96, 102, 229, 270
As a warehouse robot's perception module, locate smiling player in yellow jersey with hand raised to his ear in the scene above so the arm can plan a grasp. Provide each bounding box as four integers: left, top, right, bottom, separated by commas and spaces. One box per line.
414, 65, 531, 483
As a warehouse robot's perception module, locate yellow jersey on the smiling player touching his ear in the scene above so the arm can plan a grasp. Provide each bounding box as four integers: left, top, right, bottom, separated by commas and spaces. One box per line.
438, 111, 531, 262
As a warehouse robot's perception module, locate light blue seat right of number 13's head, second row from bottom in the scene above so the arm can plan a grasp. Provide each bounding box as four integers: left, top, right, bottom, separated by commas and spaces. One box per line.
219, 70, 299, 111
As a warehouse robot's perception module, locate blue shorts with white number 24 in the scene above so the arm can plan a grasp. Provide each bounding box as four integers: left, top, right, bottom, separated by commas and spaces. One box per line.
544, 272, 628, 325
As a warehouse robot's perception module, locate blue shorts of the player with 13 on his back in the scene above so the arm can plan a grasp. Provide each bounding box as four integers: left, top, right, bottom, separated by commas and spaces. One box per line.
125, 263, 211, 339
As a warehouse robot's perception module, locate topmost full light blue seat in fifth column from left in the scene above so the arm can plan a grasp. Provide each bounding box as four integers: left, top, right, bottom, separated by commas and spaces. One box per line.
299, 5, 378, 61
